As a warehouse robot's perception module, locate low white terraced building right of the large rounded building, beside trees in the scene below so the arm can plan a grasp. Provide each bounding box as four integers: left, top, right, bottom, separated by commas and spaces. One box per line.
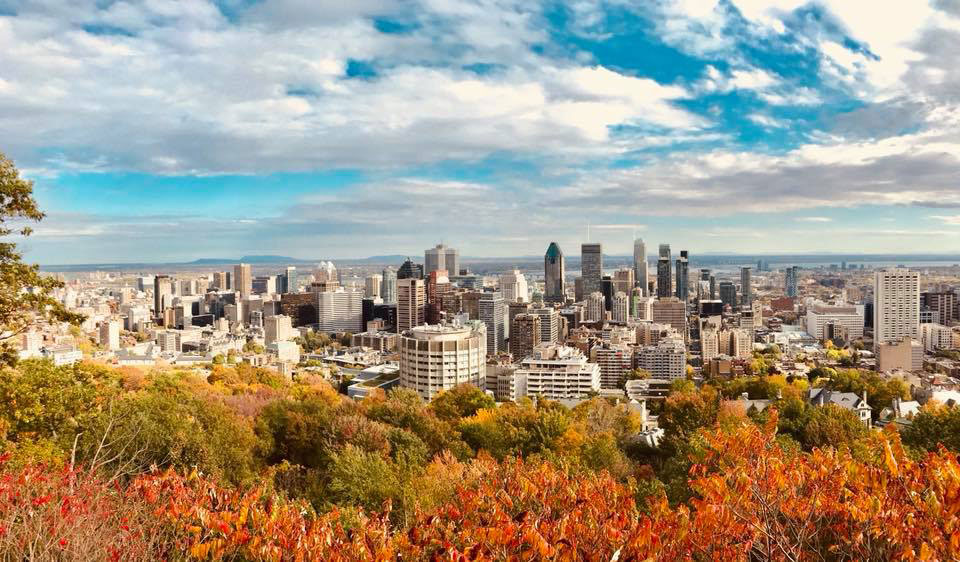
515, 344, 600, 400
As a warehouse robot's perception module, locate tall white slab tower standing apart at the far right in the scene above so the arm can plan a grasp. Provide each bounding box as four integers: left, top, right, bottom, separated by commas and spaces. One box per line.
873, 268, 920, 348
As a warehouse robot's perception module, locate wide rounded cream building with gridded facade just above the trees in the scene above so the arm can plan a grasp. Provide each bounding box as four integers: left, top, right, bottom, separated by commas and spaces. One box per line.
397, 322, 486, 400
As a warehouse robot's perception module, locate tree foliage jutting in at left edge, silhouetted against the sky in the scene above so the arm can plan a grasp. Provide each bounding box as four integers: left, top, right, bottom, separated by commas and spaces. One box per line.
0, 152, 83, 366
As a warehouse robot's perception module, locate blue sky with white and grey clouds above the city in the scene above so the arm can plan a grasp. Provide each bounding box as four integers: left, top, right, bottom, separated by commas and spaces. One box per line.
0, 0, 960, 264
